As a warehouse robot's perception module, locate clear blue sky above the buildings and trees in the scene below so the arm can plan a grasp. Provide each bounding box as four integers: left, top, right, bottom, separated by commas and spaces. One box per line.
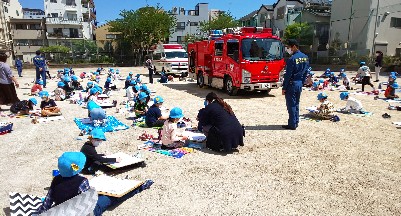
19, 0, 276, 24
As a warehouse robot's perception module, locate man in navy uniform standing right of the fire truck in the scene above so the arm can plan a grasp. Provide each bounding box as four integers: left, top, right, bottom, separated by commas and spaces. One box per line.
283, 39, 309, 130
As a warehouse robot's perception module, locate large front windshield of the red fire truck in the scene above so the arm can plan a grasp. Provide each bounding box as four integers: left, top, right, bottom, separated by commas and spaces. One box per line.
241, 38, 283, 61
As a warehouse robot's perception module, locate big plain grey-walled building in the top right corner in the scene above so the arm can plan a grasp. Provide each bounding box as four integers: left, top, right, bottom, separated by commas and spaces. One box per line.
330, 0, 401, 57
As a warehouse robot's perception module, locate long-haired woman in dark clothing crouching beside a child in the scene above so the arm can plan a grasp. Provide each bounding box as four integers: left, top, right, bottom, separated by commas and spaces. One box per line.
199, 92, 244, 152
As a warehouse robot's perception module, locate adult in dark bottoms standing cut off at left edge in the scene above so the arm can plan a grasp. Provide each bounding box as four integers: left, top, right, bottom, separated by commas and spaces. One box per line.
0, 53, 19, 110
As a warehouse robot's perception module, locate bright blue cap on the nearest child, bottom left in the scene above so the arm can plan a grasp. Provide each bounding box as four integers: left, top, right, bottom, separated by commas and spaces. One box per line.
58, 152, 86, 177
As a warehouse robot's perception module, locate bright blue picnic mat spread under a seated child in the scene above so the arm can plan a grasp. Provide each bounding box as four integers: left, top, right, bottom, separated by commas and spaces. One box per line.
74, 116, 129, 132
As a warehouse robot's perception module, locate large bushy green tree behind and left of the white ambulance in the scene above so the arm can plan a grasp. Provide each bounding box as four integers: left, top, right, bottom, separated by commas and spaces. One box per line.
109, 6, 176, 49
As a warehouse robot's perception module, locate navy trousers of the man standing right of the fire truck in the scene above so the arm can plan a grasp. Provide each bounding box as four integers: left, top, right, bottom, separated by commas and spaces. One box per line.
285, 81, 302, 128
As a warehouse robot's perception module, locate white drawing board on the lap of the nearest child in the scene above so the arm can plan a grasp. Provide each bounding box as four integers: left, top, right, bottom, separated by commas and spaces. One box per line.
89, 175, 144, 197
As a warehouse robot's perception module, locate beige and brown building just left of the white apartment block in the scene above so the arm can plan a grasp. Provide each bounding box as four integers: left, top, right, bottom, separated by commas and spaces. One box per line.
10, 18, 47, 63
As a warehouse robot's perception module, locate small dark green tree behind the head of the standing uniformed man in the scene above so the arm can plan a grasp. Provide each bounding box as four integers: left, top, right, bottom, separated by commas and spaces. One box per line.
284, 22, 314, 45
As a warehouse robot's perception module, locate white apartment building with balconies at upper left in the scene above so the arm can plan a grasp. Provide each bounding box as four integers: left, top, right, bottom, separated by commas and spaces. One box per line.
44, 0, 96, 46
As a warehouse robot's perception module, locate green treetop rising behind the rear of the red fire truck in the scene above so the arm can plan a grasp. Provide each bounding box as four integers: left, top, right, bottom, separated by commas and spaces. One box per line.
200, 12, 240, 33
